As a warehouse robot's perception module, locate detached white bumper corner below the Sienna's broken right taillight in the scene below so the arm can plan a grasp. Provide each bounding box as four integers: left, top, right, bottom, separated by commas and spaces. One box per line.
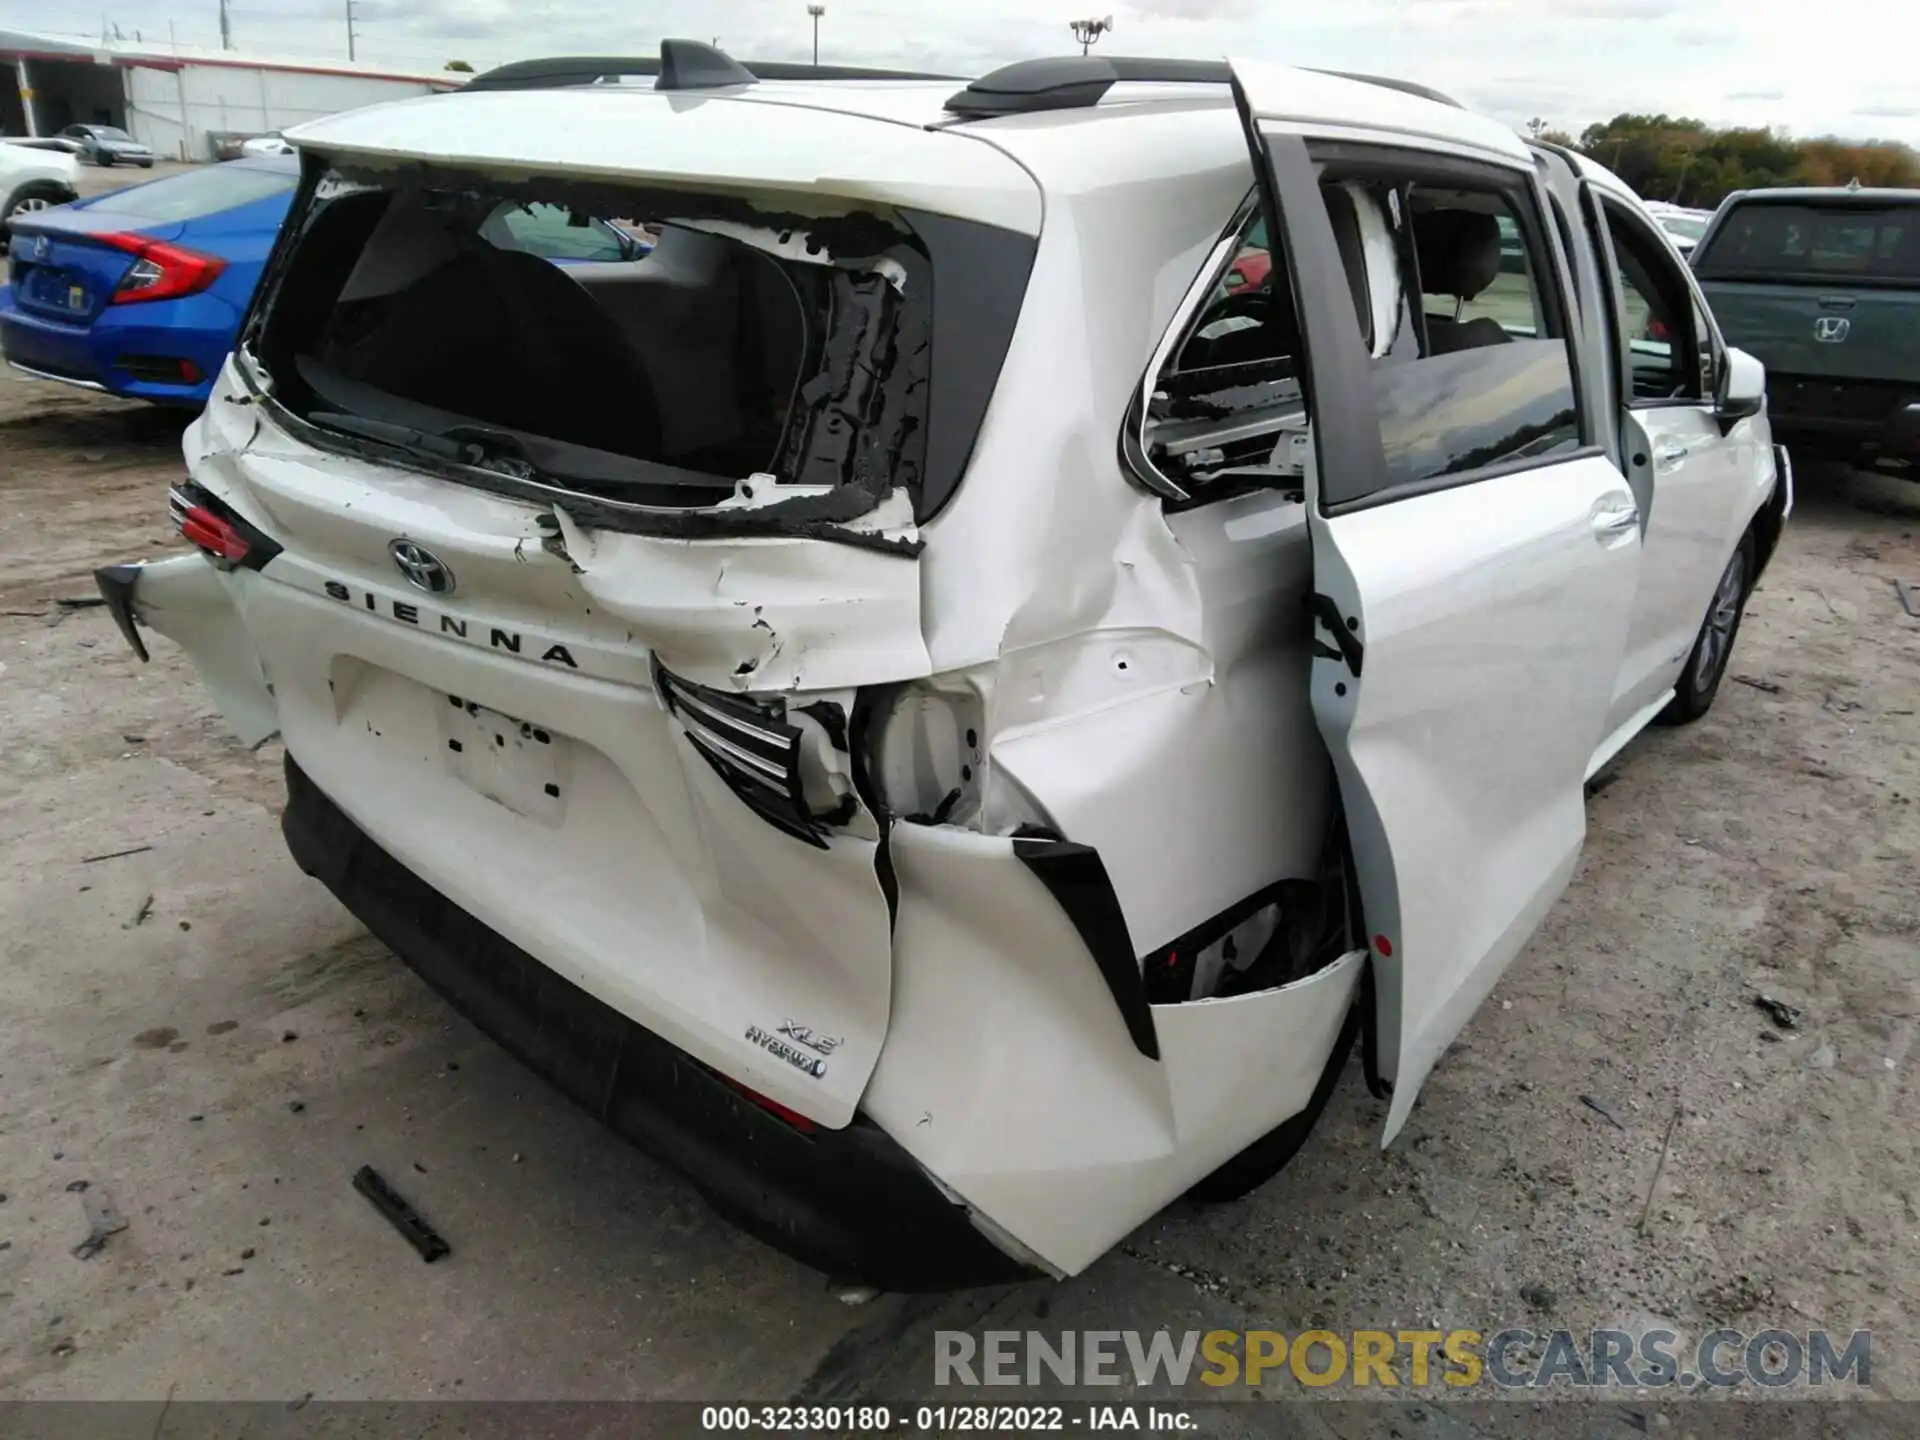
862, 824, 1365, 1275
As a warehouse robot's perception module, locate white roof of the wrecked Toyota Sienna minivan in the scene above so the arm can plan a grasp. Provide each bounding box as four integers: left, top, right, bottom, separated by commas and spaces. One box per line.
288, 58, 1526, 234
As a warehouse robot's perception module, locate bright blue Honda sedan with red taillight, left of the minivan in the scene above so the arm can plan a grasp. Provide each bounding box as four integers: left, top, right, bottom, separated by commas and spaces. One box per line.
0, 156, 300, 409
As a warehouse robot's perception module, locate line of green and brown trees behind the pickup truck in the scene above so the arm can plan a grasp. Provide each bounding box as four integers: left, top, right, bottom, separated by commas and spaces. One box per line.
1526, 115, 1920, 209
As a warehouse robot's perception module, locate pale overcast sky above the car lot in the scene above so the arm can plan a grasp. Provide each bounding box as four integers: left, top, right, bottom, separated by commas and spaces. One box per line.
15, 0, 1920, 144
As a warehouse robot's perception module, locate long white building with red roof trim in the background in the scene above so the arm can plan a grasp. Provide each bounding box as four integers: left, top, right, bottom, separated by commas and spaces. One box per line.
0, 31, 467, 159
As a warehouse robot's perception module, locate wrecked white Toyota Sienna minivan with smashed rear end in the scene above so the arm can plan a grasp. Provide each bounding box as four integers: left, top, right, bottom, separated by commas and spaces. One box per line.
100, 42, 1791, 1288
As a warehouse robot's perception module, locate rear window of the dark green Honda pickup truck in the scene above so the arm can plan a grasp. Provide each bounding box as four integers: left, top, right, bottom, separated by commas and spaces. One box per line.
1693, 202, 1920, 284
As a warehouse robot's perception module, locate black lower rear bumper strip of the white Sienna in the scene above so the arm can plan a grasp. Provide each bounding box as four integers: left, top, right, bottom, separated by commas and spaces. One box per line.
280, 755, 1033, 1290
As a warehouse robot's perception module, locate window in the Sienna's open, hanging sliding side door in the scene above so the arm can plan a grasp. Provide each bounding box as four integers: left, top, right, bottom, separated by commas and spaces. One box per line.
1321, 175, 1584, 505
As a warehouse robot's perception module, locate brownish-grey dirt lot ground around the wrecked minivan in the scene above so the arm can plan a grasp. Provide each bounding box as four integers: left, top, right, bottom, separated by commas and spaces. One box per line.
0, 362, 1920, 1436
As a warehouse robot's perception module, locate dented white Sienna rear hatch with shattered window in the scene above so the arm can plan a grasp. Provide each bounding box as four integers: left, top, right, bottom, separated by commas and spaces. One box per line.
188, 107, 1039, 1125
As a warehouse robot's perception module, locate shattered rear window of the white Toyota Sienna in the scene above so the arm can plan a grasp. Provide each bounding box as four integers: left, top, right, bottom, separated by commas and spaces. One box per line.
246, 165, 1033, 524
